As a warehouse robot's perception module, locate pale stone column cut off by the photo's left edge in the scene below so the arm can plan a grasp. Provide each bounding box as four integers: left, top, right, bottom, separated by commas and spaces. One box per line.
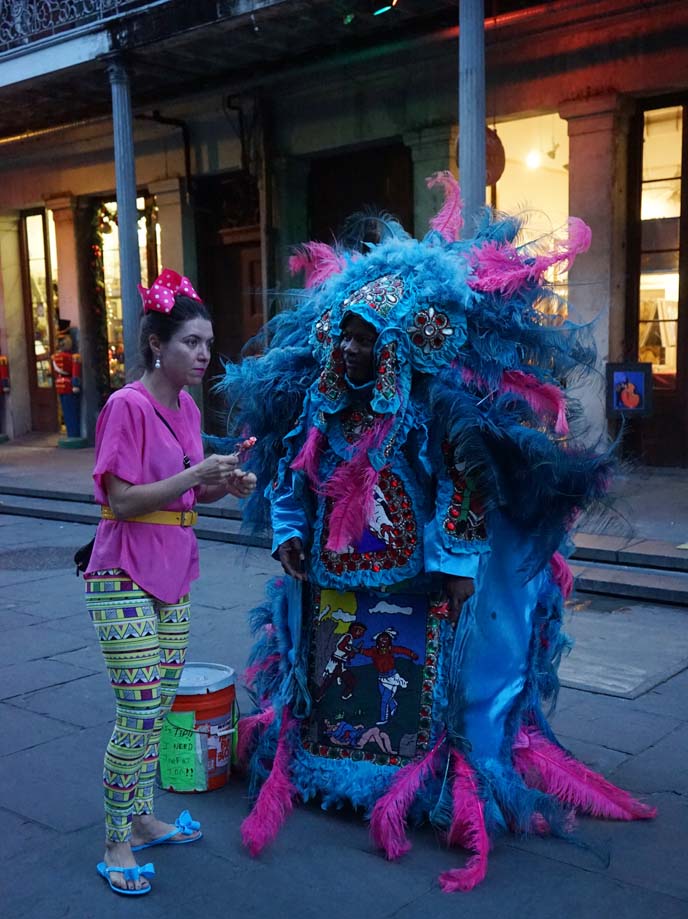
0, 214, 31, 438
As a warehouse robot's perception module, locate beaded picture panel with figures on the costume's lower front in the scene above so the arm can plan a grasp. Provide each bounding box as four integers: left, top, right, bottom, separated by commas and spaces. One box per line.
303, 590, 439, 765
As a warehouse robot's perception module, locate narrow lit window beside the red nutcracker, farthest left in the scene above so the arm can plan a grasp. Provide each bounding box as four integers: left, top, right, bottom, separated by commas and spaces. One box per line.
24, 211, 57, 389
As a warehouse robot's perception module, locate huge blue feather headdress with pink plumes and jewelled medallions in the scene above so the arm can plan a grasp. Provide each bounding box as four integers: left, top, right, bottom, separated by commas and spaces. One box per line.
208, 173, 612, 548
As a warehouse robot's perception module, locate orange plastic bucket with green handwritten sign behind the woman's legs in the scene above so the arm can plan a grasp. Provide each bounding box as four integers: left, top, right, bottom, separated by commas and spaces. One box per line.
158, 662, 238, 792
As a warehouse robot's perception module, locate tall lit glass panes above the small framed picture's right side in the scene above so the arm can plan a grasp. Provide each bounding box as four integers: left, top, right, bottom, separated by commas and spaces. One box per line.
638, 106, 683, 389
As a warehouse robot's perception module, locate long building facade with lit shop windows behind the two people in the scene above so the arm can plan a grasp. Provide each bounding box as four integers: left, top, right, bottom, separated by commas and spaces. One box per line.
0, 0, 688, 465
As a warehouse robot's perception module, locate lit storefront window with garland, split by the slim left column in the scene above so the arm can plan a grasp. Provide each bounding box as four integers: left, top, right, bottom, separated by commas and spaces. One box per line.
100, 197, 160, 389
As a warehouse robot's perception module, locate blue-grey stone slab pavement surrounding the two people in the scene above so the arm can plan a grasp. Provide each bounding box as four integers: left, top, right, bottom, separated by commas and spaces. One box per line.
0, 444, 688, 919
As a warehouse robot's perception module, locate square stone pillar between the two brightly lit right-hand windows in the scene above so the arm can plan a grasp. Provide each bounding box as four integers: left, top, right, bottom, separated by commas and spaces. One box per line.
559, 94, 630, 444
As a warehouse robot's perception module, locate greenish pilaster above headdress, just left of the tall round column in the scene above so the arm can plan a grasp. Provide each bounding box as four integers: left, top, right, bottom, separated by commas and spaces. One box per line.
404, 124, 456, 237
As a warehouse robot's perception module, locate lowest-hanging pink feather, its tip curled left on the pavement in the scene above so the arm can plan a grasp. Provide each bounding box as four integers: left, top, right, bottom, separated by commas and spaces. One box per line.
439, 750, 490, 893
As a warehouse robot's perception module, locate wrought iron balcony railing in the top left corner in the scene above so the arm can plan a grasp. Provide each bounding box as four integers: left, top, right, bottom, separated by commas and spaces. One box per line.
0, 0, 167, 54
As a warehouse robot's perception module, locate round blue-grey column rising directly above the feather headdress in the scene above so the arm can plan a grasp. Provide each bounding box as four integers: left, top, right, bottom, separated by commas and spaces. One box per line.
459, 0, 485, 238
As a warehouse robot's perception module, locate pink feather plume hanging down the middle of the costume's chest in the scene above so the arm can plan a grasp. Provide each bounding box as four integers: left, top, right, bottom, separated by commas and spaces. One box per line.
322, 419, 391, 552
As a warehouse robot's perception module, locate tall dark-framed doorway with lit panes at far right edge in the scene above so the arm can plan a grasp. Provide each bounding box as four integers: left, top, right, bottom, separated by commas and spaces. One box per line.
625, 103, 688, 466
